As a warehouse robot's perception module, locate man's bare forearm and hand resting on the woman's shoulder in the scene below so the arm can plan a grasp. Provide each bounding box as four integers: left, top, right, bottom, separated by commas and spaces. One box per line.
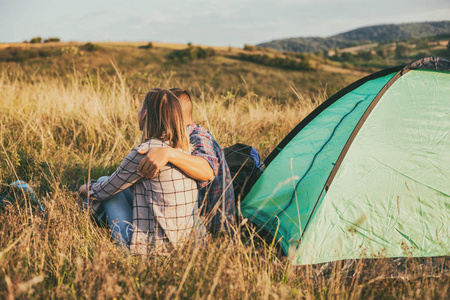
137, 147, 214, 181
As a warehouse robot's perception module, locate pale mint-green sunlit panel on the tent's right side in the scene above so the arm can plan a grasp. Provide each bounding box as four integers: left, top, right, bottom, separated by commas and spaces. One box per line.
290, 70, 450, 264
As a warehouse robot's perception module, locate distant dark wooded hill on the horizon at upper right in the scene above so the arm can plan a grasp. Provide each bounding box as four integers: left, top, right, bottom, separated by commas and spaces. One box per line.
257, 21, 450, 52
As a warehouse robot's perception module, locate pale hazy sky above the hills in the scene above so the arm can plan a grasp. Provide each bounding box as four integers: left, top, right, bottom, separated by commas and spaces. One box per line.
0, 0, 450, 47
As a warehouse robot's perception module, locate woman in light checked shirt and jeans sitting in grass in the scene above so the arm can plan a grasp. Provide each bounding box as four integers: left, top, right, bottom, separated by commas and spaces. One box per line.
80, 89, 206, 255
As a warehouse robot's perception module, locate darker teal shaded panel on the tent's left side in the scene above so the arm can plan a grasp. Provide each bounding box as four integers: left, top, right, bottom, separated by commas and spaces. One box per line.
241, 73, 394, 253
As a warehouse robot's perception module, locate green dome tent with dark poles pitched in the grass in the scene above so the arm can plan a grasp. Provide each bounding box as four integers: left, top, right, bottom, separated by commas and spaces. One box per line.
241, 57, 450, 265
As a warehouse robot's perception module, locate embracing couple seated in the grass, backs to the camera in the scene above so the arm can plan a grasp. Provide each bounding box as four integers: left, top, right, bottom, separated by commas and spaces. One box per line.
79, 89, 235, 255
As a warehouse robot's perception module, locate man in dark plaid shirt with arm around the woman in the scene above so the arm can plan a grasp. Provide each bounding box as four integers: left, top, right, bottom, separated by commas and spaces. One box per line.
138, 88, 235, 232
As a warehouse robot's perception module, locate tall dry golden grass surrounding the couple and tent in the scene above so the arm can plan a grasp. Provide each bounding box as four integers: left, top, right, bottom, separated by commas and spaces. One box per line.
0, 67, 450, 299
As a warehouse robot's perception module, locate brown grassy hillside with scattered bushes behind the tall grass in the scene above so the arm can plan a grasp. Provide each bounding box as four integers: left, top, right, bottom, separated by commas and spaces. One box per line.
0, 42, 367, 102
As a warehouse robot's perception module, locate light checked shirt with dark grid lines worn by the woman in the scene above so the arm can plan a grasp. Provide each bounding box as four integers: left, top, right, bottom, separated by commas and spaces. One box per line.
89, 139, 206, 255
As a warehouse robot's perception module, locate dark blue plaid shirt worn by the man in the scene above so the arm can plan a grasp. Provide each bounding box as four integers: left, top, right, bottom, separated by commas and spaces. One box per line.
188, 123, 236, 231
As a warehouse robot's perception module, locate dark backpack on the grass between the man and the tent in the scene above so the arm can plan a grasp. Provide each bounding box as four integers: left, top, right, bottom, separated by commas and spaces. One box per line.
223, 143, 262, 201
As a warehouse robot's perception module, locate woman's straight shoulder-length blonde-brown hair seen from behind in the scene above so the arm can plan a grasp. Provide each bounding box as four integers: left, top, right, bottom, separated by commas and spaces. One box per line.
142, 89, 189, 152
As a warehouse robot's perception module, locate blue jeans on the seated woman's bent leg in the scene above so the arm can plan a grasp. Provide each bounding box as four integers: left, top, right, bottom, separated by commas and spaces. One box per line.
86, 176, 133, 247
